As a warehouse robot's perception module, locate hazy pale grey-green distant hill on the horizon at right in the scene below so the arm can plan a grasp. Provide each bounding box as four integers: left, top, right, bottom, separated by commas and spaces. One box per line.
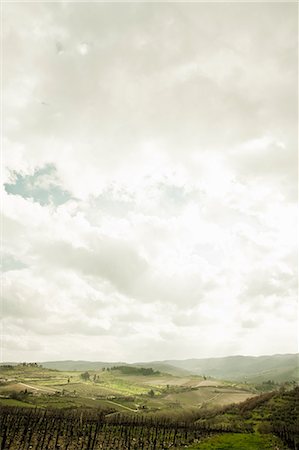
165, 354, 299, 382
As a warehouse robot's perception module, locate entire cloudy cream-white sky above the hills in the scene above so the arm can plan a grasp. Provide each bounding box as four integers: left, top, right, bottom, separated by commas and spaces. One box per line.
1, 2, 298, 362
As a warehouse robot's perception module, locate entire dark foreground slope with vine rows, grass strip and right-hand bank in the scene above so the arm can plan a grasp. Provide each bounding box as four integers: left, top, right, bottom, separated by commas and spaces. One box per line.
0, 384, 299, 450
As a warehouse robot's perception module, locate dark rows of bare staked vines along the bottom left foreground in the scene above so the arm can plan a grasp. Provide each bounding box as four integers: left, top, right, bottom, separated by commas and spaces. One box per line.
0, 407, 227, 450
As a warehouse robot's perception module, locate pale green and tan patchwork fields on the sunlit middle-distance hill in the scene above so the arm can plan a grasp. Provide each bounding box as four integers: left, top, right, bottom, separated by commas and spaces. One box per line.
0, 365, 256, 412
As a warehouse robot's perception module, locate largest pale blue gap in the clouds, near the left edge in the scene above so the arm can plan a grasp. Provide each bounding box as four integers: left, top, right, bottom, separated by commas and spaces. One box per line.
4, 164, 72, 206
